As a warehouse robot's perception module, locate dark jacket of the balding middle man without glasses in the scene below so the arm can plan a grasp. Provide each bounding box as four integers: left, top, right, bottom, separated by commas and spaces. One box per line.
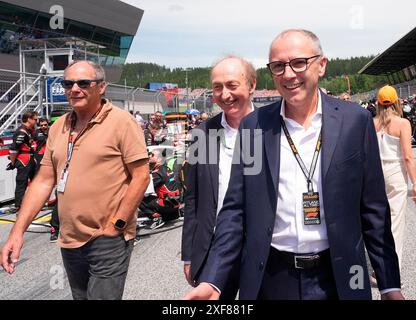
182, 108, 244, 300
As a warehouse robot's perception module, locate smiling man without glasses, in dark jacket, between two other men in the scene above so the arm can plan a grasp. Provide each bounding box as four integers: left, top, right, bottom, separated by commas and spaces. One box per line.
182, 56, 256, 300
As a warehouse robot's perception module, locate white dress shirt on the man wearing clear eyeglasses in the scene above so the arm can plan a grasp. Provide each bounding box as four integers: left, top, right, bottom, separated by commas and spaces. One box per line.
271, 93, 329, 253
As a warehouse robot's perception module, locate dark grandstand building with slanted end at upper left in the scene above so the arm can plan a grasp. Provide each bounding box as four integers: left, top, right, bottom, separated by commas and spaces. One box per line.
0, 0, 143, 82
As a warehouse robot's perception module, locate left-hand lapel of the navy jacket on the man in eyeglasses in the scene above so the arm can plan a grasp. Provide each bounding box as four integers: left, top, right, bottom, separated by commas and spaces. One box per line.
259, 102, 281, 195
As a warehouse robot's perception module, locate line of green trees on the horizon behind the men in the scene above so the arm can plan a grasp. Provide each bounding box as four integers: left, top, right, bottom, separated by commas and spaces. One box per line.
120, 56, 386, 95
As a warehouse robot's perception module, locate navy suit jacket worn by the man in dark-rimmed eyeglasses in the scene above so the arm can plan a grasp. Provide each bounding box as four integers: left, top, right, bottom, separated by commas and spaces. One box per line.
200, 94, 400, 299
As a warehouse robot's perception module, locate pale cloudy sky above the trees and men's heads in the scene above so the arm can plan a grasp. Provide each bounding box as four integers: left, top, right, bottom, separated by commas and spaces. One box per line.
123, 0, 416, 68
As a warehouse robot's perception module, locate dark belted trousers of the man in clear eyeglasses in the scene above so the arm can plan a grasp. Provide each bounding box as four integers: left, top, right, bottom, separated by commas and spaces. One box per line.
258, 247, 338, 300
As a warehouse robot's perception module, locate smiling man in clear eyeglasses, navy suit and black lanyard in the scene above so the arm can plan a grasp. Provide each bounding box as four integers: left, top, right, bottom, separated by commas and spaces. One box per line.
185, 30, 403, 300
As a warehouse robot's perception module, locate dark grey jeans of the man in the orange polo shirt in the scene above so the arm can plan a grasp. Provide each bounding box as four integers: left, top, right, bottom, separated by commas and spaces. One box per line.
61, 235, 133, 300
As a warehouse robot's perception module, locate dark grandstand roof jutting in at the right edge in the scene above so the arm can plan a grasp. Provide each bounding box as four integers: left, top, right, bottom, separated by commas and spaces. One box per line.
358, 28, 416, 75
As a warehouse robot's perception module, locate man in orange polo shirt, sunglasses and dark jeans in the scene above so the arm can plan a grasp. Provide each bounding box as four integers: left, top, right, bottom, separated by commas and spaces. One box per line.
1, 61, 149, 299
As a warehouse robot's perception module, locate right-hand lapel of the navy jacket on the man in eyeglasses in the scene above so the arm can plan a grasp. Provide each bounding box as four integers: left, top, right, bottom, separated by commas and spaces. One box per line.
321, 94, 342, 181
